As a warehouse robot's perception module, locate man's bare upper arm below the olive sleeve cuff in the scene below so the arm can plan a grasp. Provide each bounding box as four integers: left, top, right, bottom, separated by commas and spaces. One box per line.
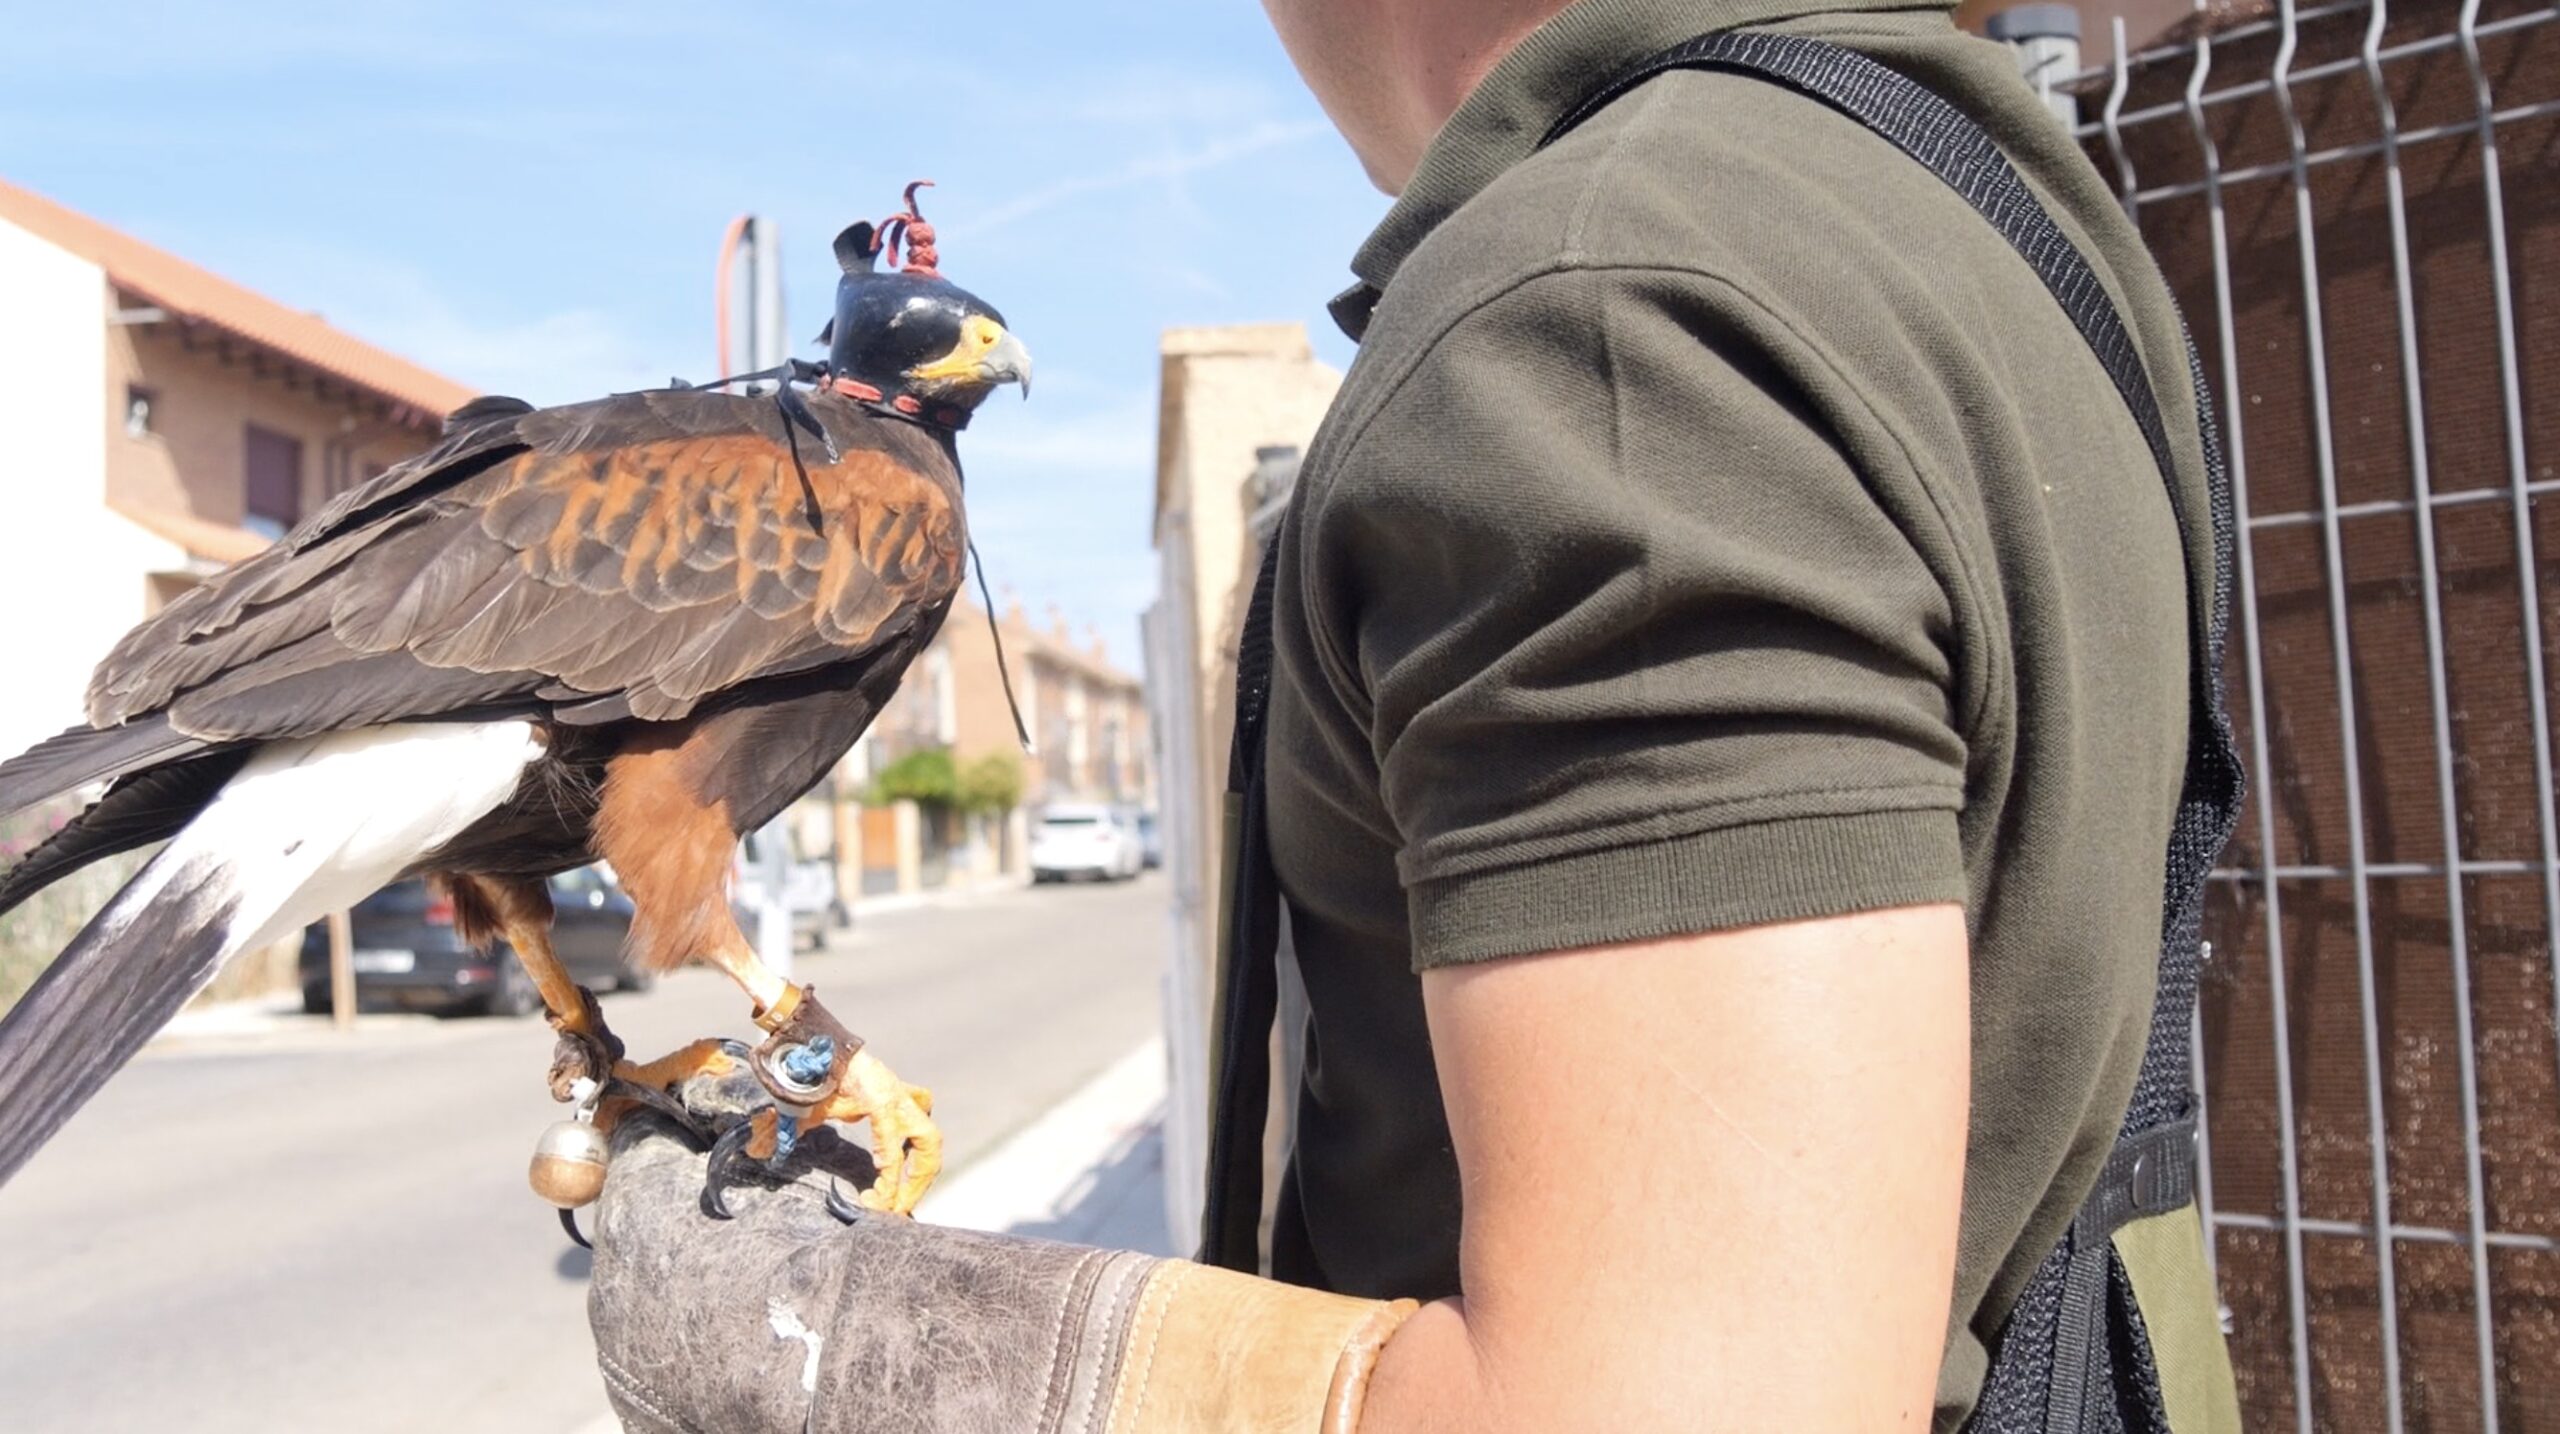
1364, 906, 1969, 1434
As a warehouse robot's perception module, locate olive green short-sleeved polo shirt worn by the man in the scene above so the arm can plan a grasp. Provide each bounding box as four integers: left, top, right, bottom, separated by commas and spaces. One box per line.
1267, 0, 2212, 1426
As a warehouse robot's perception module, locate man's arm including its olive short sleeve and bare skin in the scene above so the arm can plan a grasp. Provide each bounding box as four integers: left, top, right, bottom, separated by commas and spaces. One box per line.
1313, 271, 1969, 1431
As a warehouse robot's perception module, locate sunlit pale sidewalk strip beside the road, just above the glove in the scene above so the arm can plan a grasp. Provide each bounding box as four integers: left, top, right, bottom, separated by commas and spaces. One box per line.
919, 1037, 1165, 1229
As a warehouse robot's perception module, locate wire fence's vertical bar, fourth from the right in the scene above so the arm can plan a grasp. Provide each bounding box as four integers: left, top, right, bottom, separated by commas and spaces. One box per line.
2186, 11, 2312, 1434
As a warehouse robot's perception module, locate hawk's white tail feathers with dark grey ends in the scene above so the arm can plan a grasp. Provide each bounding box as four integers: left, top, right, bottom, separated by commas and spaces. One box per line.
0, 722, 543, 1183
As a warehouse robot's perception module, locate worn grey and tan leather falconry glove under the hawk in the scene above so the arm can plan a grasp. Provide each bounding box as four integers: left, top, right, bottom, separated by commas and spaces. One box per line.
589, 1081, 1413, 1434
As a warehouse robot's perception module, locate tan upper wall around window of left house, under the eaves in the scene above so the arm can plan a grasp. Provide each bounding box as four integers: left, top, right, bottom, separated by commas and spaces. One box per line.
105, 320, 435, 525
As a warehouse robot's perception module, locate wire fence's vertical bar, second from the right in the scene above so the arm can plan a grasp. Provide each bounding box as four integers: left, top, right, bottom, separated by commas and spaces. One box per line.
2363, 0, 2499, 1434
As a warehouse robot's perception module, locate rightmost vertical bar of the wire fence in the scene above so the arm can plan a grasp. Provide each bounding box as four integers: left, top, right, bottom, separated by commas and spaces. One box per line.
2455, 0, 2560, 1147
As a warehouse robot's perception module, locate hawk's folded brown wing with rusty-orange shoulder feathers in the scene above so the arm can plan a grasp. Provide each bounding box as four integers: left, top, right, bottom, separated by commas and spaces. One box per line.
90, 389, 968, 740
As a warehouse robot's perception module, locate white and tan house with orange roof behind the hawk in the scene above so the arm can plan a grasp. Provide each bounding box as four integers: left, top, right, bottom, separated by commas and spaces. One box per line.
0, 182, 474, 750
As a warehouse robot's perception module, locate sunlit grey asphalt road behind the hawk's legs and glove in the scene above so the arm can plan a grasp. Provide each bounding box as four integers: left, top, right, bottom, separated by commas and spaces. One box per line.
0, 876, 1165, 1434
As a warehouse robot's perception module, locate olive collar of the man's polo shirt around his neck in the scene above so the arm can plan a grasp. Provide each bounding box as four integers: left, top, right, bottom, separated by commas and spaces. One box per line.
1334, 0, 1953, 341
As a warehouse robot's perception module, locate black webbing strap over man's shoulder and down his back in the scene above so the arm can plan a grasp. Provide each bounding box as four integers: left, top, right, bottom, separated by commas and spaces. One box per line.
1541, 31, 2243, 1434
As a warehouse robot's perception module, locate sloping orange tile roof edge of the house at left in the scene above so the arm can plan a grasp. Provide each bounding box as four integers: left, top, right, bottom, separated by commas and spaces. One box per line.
0, 179, 479, 420
